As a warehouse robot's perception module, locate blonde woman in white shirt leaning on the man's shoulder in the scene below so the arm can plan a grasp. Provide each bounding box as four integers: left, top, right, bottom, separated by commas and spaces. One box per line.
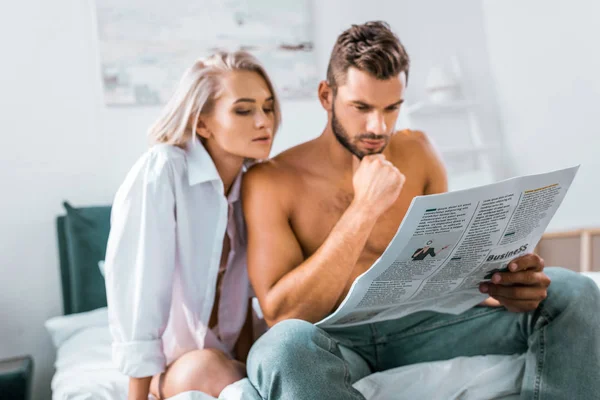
105, 52, 280, 400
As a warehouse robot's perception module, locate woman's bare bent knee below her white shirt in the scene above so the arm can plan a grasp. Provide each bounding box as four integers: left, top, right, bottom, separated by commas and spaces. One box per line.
165, 349, 245, 397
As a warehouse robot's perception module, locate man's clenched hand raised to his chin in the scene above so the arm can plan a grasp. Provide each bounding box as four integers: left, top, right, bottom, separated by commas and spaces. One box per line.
352, 154, 406, 218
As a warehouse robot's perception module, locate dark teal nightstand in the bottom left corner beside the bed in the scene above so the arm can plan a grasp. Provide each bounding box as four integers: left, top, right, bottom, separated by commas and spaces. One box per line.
0, 356, 33, 400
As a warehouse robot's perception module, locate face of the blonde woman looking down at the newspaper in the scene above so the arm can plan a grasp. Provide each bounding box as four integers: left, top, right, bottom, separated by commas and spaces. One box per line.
198, 71, 275, 159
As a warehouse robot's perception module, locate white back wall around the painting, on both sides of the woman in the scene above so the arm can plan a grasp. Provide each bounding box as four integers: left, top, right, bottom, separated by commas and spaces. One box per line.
0, 0, 497, 399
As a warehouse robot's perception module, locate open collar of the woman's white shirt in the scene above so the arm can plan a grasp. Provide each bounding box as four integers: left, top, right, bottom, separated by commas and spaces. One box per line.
186, 136, 246, 204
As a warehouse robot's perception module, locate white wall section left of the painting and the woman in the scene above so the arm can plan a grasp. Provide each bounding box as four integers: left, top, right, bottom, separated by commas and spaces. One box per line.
0, 0, 152, 399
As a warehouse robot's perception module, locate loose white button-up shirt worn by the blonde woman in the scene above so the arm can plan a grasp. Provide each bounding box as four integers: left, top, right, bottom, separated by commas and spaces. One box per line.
105, 139, 251, 377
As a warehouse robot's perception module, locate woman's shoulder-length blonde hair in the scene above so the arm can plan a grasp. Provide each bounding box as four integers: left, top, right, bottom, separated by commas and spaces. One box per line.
149, 51, 281, 147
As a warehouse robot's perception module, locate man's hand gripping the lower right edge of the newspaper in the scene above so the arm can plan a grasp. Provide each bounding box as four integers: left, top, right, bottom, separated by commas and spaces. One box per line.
479, 254, 550, 312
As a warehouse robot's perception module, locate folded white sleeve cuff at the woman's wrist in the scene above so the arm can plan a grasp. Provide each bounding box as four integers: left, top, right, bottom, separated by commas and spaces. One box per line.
112, 340, 166, 378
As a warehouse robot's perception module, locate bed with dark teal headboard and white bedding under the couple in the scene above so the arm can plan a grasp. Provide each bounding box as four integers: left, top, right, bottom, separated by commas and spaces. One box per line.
46, 203, 600, 400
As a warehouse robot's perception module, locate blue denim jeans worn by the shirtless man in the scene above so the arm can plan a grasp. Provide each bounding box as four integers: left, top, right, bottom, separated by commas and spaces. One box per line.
238, 268, 600, 400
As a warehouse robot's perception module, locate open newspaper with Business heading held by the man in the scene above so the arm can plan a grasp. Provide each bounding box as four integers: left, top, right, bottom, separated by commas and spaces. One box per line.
316, 166, 579, 327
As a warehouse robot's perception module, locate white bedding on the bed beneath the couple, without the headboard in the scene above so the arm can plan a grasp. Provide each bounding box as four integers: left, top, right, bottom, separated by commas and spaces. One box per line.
46, 273, 600, 400
